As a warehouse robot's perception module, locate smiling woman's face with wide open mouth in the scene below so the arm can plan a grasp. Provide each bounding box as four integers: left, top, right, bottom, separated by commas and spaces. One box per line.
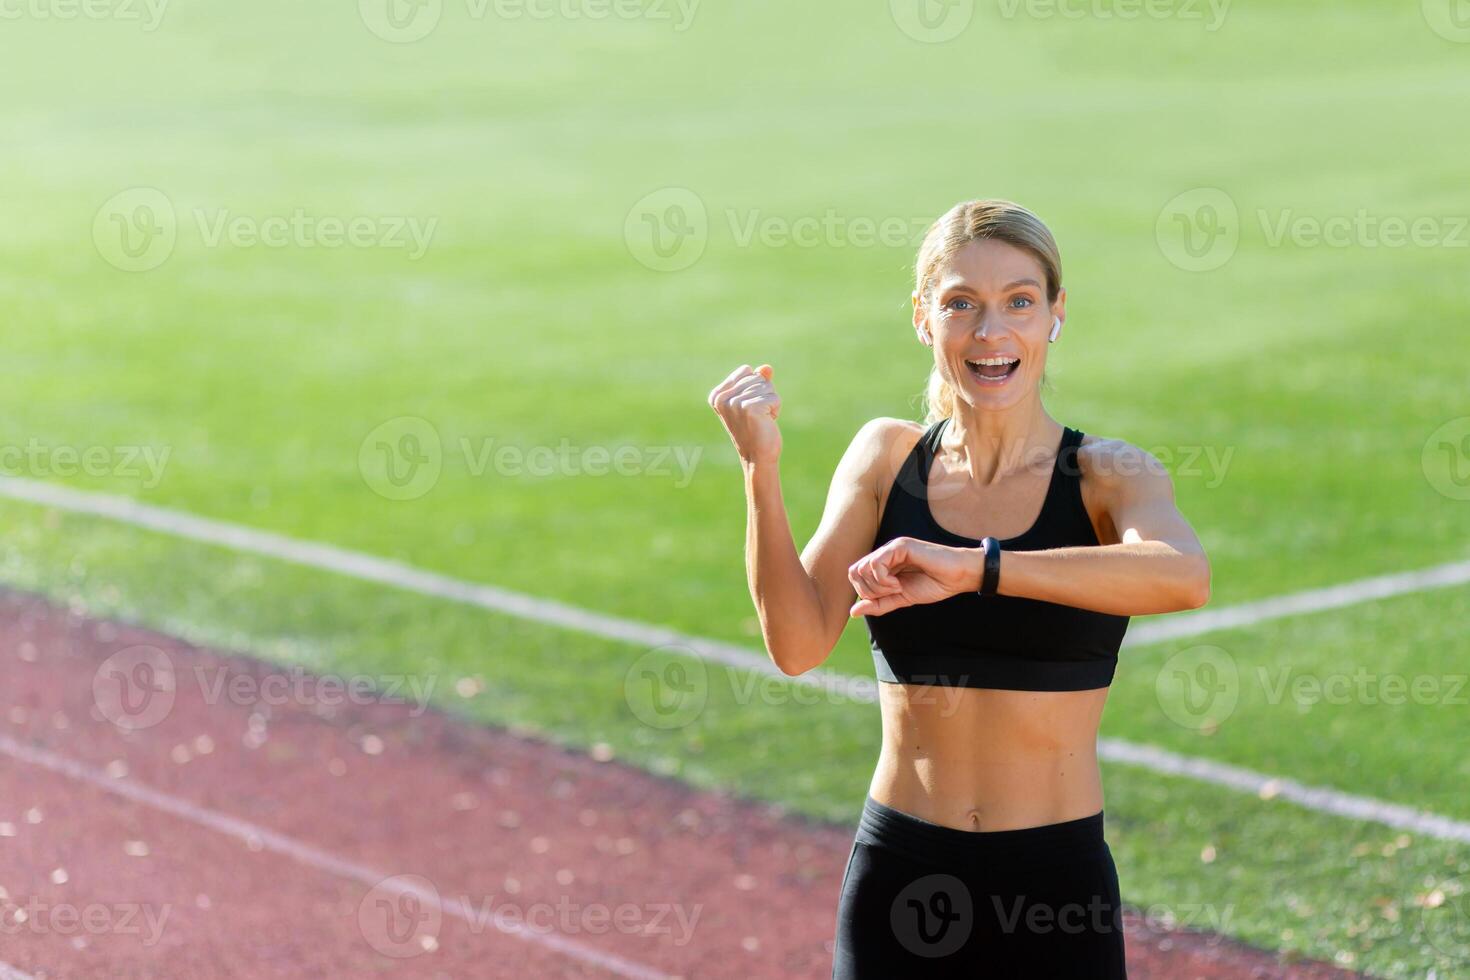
914, 239, 1067, 410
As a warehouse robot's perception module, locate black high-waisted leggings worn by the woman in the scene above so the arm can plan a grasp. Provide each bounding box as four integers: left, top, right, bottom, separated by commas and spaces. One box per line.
832, 796, 1127, 980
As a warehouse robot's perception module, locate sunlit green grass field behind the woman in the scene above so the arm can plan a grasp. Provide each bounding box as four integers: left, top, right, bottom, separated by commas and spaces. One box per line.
0, 0, 1470, 977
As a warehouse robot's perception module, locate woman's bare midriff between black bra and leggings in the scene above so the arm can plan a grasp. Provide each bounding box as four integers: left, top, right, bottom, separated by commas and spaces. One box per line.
869, 683, 1107, 830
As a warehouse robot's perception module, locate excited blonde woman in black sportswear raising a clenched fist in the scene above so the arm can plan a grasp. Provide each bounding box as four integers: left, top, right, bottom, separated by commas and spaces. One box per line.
710, 201, 1210, 979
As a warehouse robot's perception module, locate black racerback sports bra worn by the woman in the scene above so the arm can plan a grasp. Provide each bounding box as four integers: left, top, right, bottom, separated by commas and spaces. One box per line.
864, 419, 1129, 691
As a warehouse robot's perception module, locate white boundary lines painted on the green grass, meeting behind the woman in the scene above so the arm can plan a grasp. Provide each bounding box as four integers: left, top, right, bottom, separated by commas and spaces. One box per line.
0, 476, 1470, 842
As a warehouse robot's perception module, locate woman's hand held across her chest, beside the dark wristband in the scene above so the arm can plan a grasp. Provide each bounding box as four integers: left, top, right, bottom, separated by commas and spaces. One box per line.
847, 538, 985, 617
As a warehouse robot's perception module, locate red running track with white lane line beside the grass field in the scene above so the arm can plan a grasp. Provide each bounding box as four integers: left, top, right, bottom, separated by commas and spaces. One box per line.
0, 595, 1348, 980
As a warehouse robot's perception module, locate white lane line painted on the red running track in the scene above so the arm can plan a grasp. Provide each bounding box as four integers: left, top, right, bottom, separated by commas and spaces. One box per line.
0, 735, 672, 980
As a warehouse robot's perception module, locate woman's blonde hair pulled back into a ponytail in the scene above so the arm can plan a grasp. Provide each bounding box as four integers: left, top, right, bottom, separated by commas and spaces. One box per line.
914, 200, 1061, 423
